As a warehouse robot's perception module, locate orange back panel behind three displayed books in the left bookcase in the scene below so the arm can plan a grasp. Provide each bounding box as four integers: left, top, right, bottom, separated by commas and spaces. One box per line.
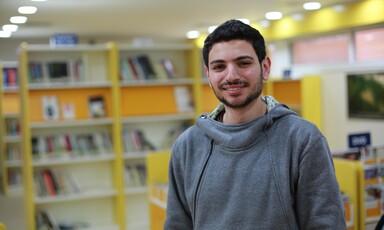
29, 88, 112, 122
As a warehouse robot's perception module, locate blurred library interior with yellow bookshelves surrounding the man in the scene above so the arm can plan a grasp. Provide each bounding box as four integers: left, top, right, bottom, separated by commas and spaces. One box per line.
0, 0, 384, 230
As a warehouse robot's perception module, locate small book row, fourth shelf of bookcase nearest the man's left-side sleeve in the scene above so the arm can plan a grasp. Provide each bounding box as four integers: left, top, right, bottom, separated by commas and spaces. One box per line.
124, 163, 147, 187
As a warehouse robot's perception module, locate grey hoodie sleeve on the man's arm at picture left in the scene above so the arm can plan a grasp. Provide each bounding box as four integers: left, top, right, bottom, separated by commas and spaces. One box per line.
164, 136, 193, 230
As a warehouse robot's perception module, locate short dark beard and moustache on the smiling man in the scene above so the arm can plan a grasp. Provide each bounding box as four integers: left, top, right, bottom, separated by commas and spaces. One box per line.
212, 71, 263, 109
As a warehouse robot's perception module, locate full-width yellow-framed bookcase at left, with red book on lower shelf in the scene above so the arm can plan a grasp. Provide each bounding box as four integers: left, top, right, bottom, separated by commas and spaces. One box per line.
19, 43, 126, 230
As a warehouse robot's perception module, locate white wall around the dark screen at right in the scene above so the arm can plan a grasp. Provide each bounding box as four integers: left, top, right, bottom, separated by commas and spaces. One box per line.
271, 42, 384, 150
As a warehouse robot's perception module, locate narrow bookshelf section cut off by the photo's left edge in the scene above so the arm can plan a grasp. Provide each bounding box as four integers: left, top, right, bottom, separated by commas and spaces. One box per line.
0, 62, 22, 195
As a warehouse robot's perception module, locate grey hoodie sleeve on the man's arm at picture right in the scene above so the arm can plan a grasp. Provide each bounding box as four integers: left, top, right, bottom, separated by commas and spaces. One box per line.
296, 137, 346, 230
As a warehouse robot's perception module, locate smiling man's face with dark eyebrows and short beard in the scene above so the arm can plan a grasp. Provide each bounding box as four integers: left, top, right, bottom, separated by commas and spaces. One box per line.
205, 40, 271, 108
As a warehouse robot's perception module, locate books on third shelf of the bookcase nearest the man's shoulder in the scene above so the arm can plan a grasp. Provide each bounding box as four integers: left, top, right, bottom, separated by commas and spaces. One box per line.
123, 128, 156, 153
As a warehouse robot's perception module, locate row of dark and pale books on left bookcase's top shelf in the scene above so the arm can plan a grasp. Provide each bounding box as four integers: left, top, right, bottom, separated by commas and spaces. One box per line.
28, 59, 85, 83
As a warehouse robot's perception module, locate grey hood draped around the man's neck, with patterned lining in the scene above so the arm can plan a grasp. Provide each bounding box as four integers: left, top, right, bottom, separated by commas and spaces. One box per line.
196, 97, 296, 151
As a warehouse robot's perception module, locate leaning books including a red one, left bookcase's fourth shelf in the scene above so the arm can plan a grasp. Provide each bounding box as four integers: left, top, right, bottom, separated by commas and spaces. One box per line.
34, 169, 81, 197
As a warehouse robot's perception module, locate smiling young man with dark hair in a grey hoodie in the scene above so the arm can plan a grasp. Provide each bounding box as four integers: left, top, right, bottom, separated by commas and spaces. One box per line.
164, 20, 346, 230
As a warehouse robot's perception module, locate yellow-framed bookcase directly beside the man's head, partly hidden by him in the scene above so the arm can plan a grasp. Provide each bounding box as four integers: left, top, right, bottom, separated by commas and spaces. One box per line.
118, 44, 201, 229
